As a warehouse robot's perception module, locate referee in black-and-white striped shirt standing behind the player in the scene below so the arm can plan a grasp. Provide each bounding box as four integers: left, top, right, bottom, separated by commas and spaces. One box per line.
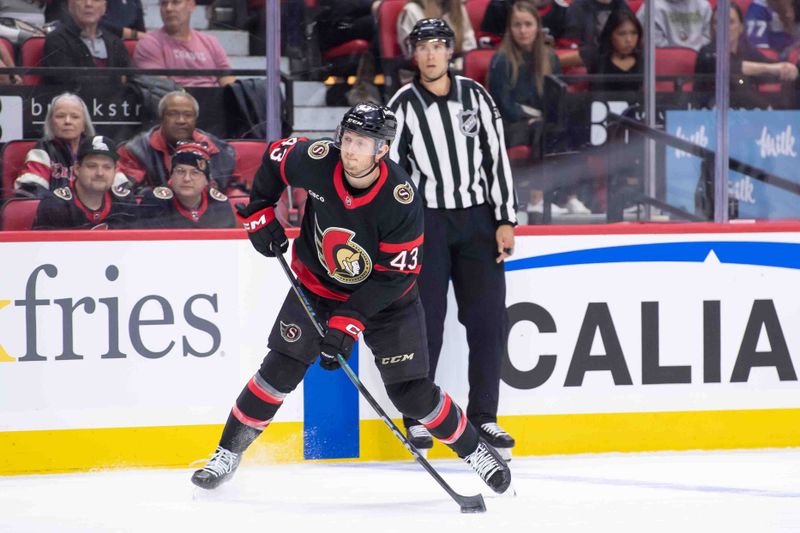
389, 19, 516, 457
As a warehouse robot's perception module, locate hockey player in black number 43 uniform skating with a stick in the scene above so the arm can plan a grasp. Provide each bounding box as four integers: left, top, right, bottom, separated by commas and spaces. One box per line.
192, 104, 511, 493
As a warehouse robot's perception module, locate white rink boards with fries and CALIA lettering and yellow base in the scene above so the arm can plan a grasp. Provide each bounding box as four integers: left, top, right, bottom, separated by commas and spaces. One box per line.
0, 223, 800, 474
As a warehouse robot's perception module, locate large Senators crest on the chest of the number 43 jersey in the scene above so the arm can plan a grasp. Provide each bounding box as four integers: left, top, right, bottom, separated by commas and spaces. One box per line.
314, 215, 372, 285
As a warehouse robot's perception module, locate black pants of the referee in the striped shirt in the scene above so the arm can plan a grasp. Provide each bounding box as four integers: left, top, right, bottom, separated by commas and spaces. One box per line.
405, 205, 508, 425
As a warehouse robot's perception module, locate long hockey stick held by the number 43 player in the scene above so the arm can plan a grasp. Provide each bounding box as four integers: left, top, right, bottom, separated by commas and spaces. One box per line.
272, 245, 486, 513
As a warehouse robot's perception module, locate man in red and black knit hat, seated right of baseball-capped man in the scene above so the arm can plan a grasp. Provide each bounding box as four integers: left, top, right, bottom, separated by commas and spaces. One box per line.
142, 143, 234, 229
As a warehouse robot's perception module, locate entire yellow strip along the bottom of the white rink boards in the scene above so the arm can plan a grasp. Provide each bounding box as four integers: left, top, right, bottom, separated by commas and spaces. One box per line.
0, 409, 800, 475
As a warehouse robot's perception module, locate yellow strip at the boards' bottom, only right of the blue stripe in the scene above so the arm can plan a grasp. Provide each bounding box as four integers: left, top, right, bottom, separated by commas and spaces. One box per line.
361, 409, 800, 461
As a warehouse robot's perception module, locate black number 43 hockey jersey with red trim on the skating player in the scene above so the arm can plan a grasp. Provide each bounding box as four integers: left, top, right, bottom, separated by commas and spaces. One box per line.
250, 137, 424, 323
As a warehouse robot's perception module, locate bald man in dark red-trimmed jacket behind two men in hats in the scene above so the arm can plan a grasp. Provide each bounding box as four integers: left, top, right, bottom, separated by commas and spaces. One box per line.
119, 91, 236, 191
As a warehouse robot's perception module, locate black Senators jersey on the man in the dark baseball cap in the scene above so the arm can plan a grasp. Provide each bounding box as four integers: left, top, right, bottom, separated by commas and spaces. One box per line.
33, 185, 137, 229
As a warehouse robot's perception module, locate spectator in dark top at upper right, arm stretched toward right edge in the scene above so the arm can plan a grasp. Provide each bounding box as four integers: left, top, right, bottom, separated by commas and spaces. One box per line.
695, 4, 797, 108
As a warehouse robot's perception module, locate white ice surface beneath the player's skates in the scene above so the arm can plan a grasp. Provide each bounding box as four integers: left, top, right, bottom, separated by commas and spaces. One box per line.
0, 449, 800, 533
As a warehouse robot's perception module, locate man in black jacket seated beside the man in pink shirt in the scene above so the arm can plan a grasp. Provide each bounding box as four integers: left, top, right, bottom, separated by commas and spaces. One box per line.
42, 0, 131, 88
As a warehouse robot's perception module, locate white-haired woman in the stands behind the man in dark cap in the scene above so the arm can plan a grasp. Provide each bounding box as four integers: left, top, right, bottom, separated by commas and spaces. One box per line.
14, 93, 127, 197
